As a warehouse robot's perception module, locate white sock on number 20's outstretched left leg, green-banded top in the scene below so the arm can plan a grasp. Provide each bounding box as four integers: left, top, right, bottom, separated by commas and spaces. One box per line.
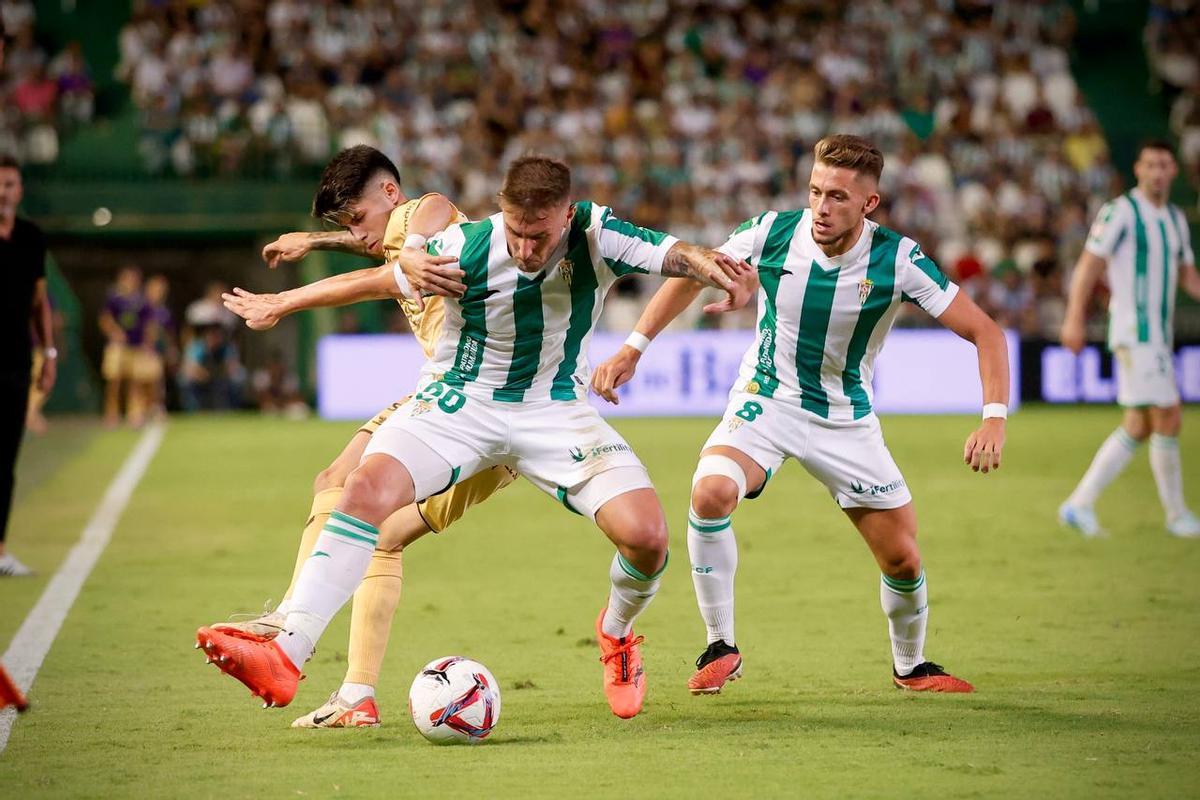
275, 511, 379, 669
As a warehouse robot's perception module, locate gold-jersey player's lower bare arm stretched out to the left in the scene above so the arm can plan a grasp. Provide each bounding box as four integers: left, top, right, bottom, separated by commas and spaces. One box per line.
221, 264, 401, 331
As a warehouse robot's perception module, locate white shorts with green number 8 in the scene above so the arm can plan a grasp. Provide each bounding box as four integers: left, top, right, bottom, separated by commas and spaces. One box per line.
704, 392, 912, 509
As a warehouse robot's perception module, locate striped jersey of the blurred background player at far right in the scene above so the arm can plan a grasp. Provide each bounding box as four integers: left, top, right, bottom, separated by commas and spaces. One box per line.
1086, 190, 1195, 348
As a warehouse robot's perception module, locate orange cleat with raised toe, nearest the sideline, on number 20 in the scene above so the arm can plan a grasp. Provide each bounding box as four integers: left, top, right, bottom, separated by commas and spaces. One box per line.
196, 627, 301, 709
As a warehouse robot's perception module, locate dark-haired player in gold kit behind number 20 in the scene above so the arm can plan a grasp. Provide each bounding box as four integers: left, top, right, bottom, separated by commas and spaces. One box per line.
215, 146, 516, 728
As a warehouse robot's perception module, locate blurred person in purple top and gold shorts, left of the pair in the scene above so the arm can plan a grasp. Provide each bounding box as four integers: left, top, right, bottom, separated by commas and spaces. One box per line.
100, 265, 162, 427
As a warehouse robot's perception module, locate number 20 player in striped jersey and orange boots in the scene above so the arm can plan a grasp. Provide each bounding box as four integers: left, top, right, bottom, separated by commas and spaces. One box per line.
198, 156, 756, 717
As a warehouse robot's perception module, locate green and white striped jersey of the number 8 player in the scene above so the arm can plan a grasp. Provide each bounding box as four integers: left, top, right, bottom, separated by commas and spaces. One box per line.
720, 209, 958, 421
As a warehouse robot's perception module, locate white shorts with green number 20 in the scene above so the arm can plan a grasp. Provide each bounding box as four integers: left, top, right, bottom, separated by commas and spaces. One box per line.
362, 381, 653, 518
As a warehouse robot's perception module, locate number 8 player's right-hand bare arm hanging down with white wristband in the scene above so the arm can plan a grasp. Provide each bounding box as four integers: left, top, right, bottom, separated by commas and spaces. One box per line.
937, 291, 1009, 473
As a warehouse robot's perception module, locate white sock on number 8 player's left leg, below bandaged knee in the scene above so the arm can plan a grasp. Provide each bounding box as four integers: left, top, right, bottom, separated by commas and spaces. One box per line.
688, 510, 738, 645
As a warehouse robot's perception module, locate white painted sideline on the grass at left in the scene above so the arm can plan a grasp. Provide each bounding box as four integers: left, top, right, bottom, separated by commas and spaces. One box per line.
0, 422, 167, 754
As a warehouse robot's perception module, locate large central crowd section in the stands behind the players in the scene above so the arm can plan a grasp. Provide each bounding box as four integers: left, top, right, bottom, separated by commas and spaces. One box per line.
112, 0, 1116, 335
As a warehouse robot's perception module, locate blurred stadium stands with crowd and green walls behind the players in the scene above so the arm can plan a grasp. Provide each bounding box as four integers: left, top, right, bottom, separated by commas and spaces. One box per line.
0, 0, 1200, 414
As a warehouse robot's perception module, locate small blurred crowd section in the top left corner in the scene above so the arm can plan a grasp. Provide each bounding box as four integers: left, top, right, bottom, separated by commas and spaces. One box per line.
0, 0, 95, 164
